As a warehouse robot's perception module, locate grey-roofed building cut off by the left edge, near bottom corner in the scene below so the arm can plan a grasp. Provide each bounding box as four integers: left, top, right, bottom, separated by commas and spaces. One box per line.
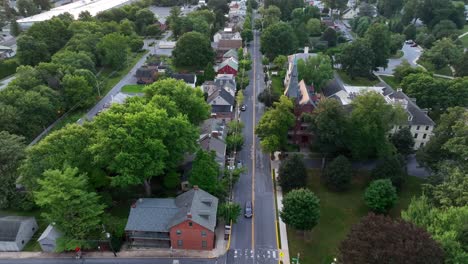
0, 216, 37, 251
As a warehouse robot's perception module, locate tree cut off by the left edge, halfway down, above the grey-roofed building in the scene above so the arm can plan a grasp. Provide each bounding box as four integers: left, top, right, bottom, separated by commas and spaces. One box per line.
0, 131, 26, 209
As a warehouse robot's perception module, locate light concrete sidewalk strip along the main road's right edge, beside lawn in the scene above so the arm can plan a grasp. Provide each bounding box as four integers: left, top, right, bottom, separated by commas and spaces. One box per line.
271, 152, 290, 264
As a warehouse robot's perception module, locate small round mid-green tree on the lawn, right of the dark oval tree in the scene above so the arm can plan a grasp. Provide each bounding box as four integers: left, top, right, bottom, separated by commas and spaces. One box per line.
364, 179, 397, 213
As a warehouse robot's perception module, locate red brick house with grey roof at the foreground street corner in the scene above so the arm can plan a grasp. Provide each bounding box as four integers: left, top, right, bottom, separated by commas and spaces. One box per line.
125, 186, 218, 250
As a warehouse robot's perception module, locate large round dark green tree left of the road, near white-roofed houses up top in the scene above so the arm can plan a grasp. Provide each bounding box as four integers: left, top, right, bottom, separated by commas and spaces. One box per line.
172, 32, 214, 69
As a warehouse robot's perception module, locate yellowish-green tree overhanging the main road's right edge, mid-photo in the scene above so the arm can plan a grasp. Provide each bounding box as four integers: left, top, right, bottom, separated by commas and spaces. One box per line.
255, 96, 295, 153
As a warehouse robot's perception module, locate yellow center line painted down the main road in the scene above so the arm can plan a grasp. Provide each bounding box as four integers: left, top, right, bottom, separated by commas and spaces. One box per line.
252, 29, 257, 250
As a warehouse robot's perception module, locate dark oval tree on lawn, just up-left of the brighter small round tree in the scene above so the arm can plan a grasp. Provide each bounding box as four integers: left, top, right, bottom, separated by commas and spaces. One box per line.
322, 155, 353, 191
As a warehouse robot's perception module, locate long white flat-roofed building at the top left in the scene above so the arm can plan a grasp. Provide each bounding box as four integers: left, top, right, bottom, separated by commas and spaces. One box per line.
17, 0, 132, 29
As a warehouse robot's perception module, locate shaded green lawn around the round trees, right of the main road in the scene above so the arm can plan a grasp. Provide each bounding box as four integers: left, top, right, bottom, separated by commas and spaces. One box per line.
288, 170, 422, 264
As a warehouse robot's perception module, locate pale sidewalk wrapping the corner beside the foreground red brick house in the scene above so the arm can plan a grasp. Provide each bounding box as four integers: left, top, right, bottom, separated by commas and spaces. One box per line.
0, 222, 228, 259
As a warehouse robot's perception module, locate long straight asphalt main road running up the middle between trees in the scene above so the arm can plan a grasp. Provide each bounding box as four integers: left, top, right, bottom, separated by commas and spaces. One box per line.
227, 12, 279, 264
